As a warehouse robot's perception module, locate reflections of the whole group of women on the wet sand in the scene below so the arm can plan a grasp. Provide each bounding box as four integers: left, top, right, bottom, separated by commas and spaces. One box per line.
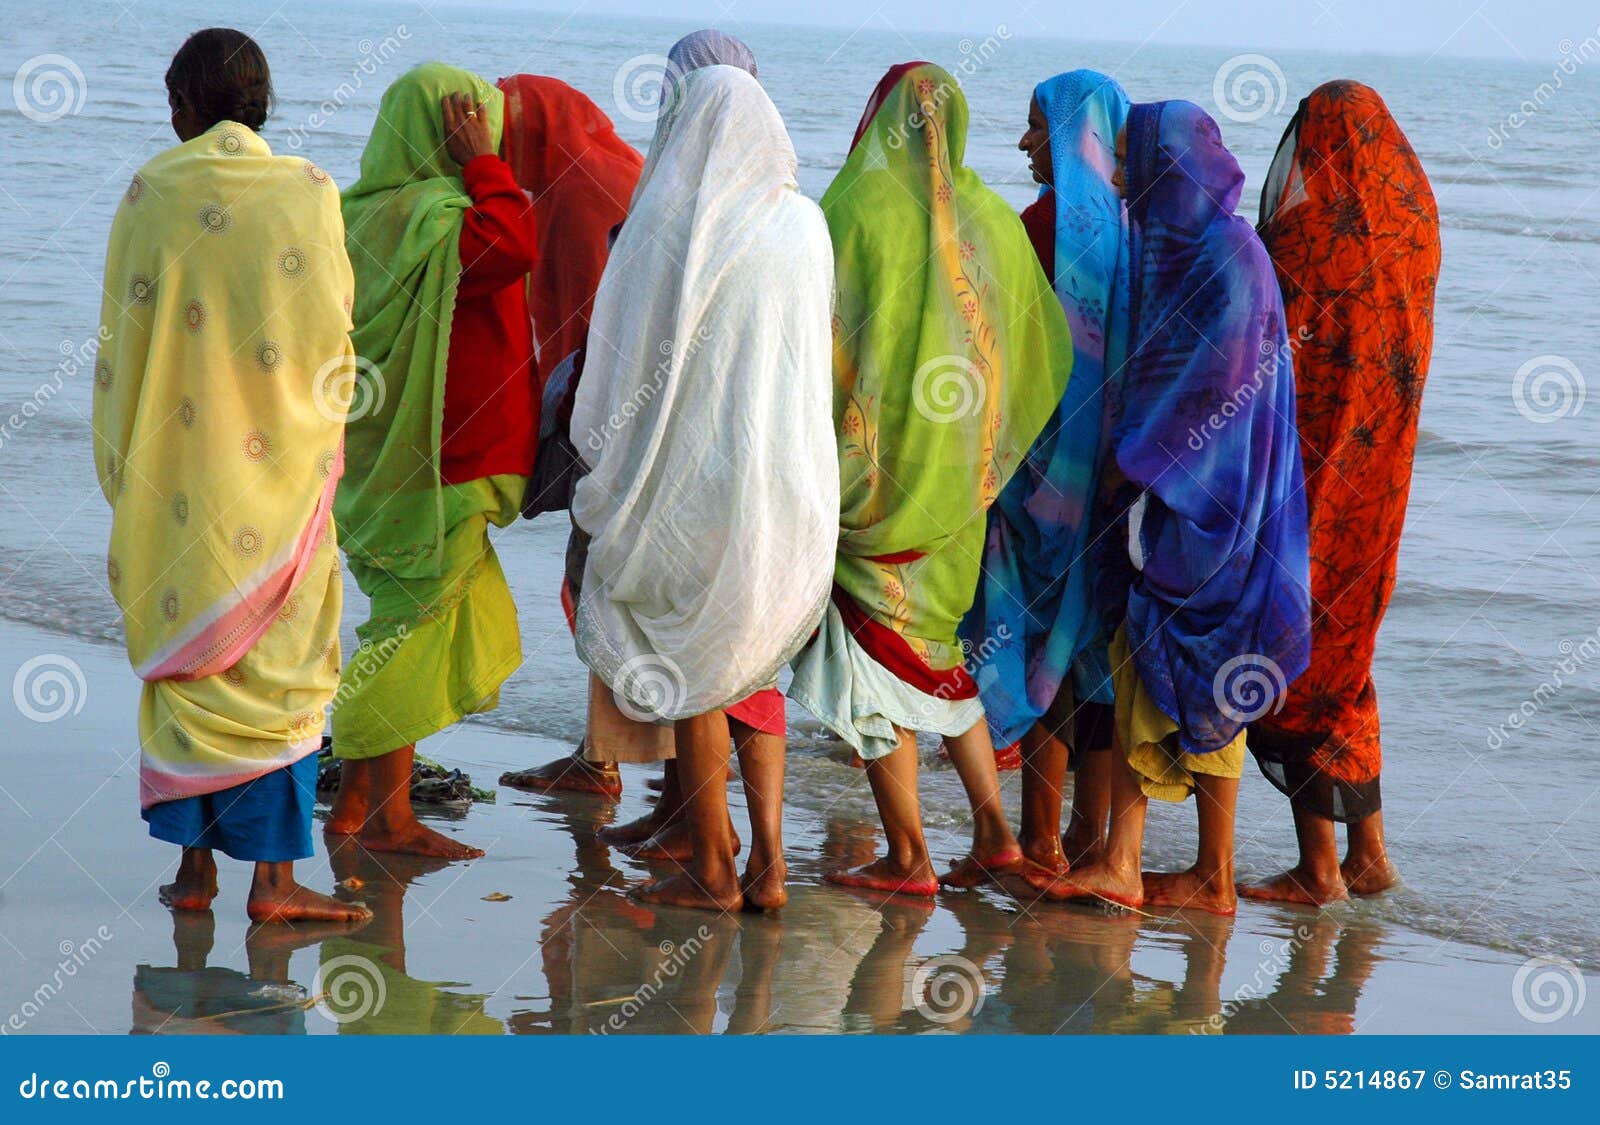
133, 797, 1382, 1035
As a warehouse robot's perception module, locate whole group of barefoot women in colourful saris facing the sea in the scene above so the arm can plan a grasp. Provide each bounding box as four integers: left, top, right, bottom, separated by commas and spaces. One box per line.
96, 29, 1438, 919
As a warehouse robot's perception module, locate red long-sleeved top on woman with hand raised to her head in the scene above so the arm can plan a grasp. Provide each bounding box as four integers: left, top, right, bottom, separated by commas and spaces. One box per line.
438, 155, 539, 485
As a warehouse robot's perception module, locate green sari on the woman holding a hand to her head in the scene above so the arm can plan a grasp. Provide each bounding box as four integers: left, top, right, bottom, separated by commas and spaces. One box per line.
333, 62, 525, 759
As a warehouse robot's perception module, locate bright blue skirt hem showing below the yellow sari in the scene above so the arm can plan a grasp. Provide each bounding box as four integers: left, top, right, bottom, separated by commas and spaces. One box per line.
142, 754, 317, 863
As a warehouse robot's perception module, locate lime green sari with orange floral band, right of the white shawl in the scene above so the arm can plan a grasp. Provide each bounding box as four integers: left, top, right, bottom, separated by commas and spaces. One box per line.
822, 62, 1072, 671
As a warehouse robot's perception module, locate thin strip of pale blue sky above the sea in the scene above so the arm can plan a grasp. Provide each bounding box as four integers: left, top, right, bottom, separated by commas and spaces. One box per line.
434, 0, 1600, 59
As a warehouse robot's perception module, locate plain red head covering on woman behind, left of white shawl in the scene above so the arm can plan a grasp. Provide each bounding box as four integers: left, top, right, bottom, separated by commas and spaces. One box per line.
499, 74, 645, 390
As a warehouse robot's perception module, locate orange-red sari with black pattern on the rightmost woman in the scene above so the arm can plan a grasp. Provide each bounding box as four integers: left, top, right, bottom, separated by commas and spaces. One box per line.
1250, 82, 1440, 821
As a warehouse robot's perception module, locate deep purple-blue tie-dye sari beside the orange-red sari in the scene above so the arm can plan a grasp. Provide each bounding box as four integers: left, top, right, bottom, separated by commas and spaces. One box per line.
1096, 101, 1310, 754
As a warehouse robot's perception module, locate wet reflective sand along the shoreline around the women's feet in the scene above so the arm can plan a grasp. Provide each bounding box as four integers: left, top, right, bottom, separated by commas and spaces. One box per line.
0, 623, 1600, 1034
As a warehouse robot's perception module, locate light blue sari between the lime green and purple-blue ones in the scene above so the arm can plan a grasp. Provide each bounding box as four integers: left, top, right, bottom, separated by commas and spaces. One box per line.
962, 70, 1128, 746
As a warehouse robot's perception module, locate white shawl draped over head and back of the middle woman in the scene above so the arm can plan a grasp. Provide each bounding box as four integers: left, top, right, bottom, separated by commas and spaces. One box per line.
571, 66, 838, 720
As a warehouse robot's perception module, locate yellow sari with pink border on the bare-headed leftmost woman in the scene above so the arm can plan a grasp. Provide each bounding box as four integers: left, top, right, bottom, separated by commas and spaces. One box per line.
94, 122, 354, 808
